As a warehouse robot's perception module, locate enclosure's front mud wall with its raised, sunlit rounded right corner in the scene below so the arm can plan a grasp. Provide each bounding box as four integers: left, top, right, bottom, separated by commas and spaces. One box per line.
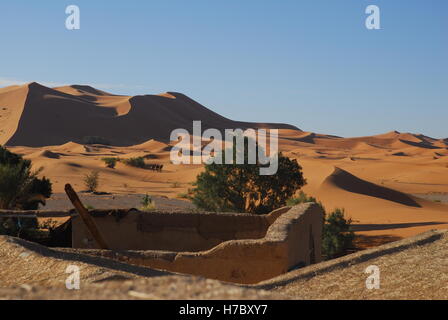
74, 203, 323, 284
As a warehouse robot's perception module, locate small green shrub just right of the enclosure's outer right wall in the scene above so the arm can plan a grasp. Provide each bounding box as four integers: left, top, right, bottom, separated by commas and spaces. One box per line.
322, 209, 355, 259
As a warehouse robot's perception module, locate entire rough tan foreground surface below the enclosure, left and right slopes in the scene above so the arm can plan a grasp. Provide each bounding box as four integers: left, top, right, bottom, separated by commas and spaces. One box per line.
0, 230, 448, 300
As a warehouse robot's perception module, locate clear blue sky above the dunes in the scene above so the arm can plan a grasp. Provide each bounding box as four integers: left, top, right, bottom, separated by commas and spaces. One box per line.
0, 0, 448, 138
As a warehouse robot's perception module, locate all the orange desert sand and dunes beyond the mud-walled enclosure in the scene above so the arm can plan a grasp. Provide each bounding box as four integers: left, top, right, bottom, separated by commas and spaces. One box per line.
0, 83, 448, 246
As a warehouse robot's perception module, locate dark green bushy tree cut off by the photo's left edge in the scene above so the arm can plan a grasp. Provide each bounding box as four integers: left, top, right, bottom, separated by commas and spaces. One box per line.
0, 146, 52, 210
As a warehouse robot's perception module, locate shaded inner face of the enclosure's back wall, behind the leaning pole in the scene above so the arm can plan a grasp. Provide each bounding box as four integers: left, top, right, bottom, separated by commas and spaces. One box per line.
72, 210, 285, 252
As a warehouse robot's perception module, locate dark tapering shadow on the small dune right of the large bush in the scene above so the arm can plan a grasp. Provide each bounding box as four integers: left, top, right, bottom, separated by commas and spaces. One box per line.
324, 167, 421, 208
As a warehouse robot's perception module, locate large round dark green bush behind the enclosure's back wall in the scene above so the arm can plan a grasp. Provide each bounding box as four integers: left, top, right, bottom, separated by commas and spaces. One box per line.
192, 138, 306, 214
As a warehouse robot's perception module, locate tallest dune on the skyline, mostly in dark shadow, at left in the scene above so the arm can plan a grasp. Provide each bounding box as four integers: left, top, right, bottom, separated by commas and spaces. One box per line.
0, 83, 298, 147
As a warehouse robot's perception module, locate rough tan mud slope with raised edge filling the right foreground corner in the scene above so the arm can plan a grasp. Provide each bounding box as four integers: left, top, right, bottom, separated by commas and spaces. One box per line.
261, 231, 448, 300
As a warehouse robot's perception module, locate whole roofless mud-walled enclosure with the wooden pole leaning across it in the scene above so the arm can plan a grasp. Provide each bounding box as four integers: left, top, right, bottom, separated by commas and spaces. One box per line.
0, 203, 323, 284
